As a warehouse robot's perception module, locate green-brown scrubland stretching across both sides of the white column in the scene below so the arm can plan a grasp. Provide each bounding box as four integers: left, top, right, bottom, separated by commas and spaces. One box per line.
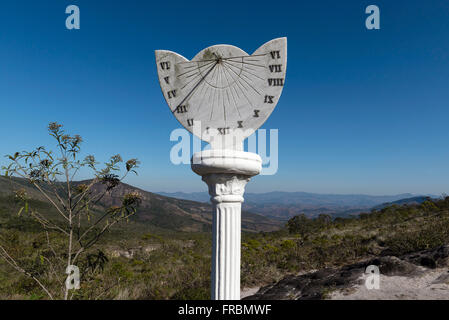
0, 198, 449, 299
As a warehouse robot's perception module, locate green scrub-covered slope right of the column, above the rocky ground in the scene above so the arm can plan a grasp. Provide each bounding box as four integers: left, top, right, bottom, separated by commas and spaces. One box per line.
242, 197, 449, 286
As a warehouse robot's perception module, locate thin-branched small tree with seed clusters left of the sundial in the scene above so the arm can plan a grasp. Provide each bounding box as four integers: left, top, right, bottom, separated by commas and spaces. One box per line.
0, 122, 141, 300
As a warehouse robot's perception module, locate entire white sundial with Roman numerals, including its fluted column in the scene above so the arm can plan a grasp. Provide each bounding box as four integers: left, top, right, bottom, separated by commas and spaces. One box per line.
156, 38, 287, 300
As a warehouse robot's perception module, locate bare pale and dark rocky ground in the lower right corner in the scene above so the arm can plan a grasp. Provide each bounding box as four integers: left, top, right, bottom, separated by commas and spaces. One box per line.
244, 245, 449, 300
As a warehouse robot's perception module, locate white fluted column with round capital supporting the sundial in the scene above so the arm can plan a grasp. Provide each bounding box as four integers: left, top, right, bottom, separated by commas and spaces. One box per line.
192, 150, 262, 300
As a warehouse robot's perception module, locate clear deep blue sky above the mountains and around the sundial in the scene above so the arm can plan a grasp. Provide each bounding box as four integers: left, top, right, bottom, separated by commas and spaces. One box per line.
0, 0, 449, 194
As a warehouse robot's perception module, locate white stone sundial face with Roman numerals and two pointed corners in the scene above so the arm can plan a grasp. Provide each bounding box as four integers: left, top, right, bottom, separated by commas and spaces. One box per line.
156, 38, 287, 149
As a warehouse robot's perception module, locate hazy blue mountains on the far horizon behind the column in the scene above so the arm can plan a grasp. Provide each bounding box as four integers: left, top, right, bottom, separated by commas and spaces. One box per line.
158, 191, 434, 221
